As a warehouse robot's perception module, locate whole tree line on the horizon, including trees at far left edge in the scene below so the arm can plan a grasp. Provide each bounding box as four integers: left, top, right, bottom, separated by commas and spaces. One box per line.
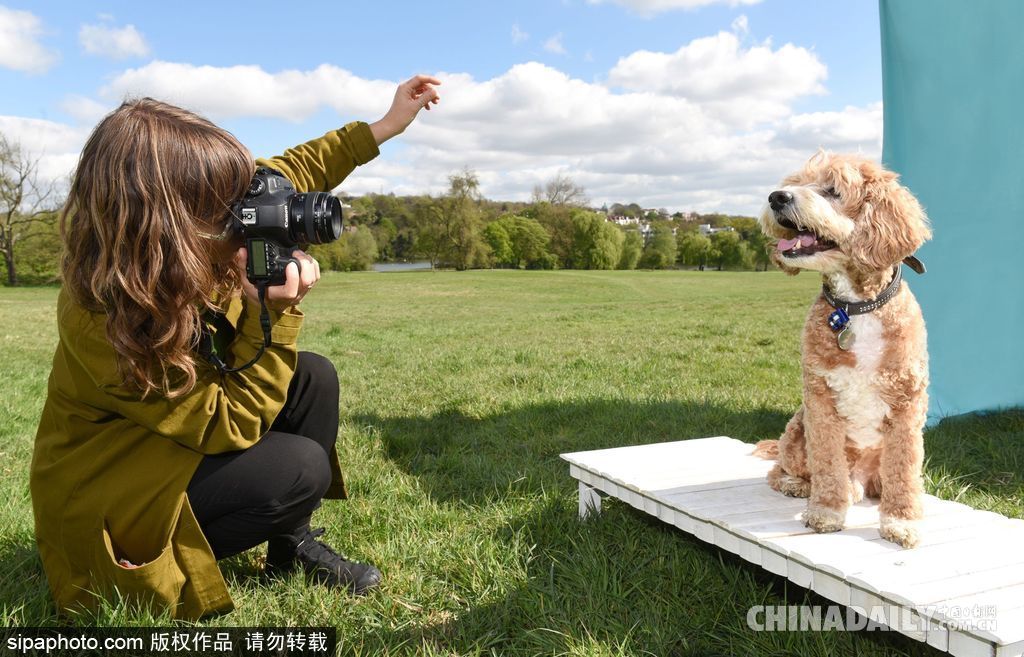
0, 135, 769, 286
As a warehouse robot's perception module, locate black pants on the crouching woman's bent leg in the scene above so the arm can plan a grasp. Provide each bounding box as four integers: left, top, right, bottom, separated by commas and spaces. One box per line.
187, 352, 338, 559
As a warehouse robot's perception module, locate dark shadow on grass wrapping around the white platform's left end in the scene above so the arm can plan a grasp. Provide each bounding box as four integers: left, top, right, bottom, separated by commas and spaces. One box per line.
352, 400, 939, 656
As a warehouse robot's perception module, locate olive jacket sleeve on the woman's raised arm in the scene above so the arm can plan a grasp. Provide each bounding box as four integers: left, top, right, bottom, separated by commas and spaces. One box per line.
256, 121, 380, 191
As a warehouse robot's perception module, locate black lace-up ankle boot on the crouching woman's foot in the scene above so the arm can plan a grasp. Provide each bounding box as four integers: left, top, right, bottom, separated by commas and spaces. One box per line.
263, 526, 381, 596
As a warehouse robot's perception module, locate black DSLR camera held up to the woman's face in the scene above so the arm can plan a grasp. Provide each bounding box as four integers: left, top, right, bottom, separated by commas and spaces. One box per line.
231, 167, 342, 286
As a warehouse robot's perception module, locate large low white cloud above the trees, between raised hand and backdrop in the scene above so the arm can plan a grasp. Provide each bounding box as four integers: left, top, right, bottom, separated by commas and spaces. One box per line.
343, 62, 882, 213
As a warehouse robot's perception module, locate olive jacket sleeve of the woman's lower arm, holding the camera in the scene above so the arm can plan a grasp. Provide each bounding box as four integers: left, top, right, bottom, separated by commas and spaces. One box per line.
81, 300, 302, 454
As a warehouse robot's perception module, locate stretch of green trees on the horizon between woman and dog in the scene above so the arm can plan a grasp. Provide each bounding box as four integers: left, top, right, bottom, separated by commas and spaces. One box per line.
310, 170, 770, 270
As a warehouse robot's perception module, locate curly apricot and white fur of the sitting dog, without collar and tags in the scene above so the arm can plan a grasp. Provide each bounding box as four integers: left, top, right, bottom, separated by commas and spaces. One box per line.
756, 152, 931, 546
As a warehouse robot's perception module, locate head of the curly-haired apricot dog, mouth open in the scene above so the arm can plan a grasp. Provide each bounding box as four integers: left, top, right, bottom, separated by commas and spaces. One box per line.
761, 151, 932, 274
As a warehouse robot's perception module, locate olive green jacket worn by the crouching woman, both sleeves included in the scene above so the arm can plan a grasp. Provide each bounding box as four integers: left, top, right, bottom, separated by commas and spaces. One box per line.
30, 123, 378, 619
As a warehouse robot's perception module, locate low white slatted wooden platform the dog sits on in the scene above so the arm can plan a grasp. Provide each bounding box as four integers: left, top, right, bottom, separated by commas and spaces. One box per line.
562, 437, 1024, 657
